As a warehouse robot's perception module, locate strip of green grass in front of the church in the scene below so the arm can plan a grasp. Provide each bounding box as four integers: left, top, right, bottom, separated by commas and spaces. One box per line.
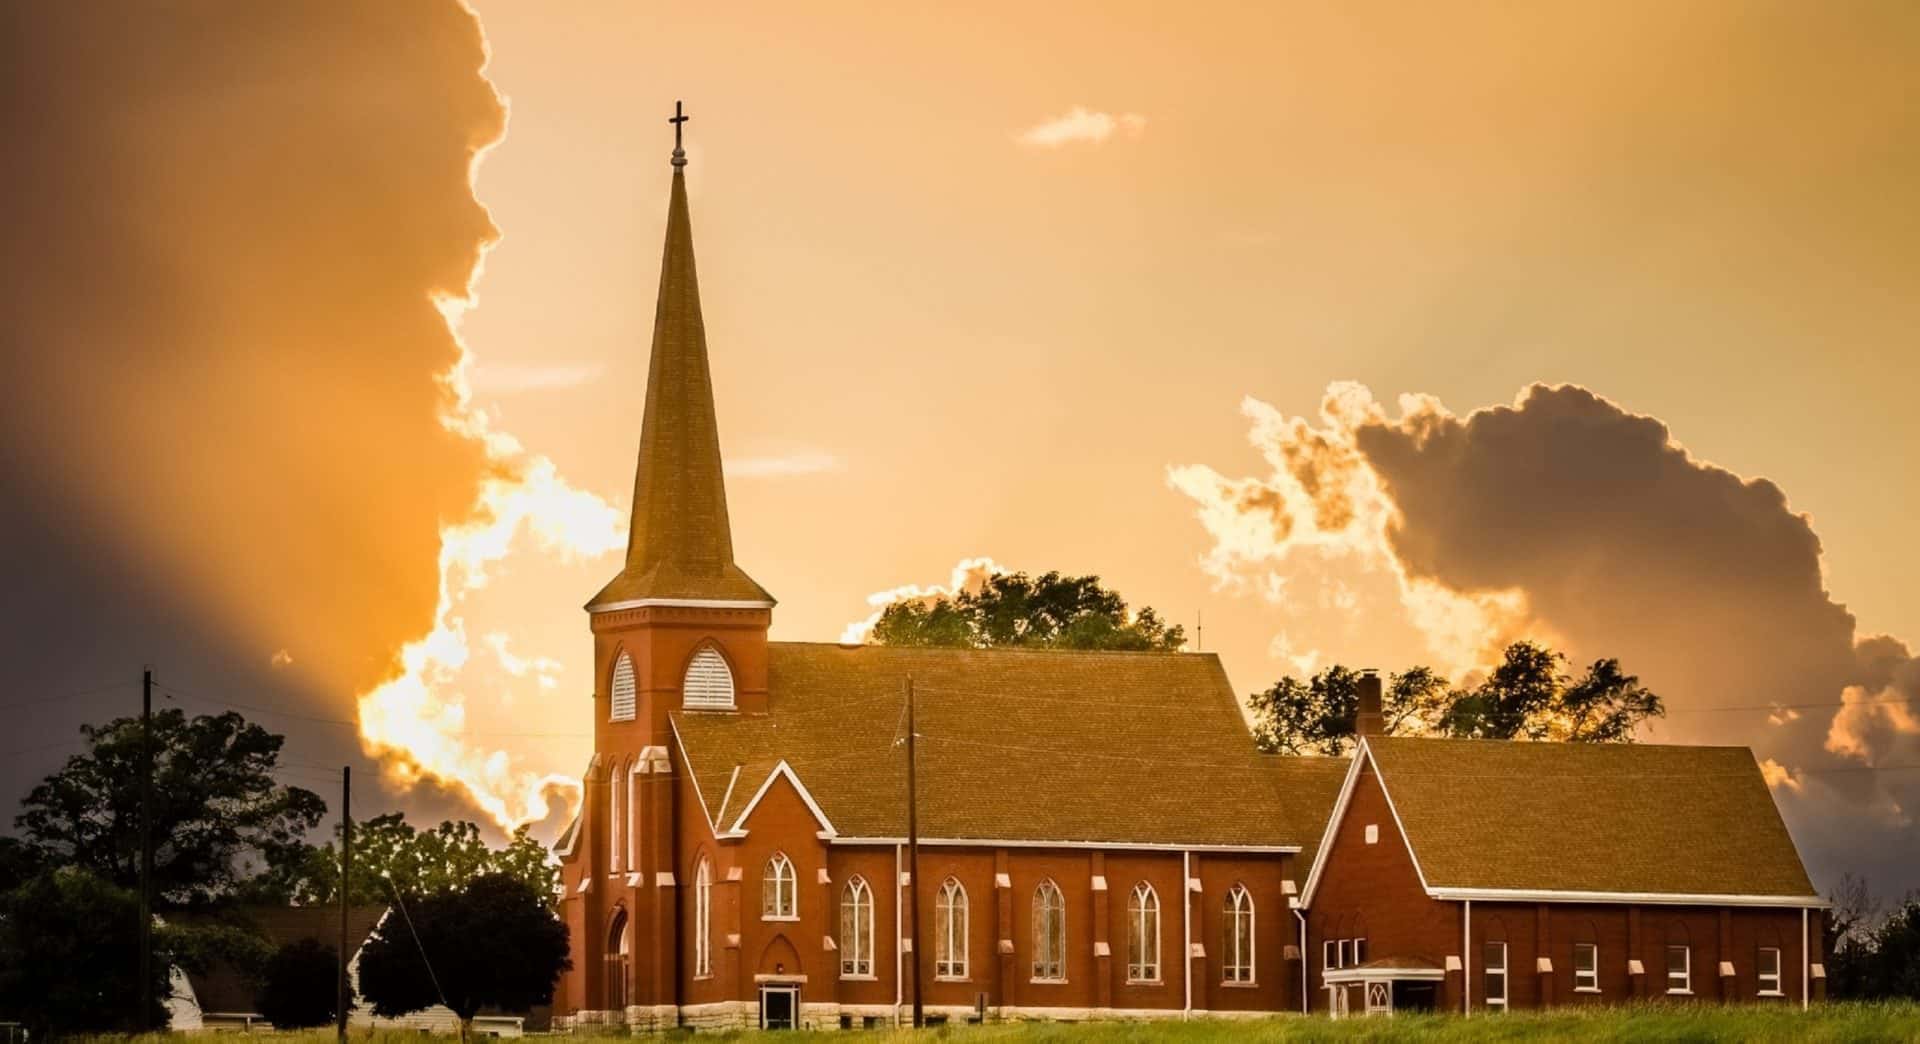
82, 1002, 1920, 1044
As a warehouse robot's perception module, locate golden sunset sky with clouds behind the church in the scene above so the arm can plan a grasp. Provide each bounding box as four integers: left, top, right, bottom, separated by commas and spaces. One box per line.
0, 0, 1920, 892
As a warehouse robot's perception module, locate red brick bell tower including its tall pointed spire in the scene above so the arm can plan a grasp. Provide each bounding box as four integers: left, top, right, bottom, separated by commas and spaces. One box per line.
563, 104, 774, 1027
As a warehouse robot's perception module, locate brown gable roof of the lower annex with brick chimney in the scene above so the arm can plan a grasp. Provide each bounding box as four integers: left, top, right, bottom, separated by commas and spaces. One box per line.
1306, 737, 1818, 904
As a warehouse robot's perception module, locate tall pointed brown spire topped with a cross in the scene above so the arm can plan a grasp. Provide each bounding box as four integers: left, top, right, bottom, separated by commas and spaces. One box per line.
588, 102, 774, 610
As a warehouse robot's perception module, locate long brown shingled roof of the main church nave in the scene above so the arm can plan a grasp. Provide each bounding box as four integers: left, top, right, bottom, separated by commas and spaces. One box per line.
674, 643, 1346, 850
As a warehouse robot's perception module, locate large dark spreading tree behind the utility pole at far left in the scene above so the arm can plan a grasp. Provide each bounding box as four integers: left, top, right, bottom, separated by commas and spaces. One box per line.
15, 708, 326, 906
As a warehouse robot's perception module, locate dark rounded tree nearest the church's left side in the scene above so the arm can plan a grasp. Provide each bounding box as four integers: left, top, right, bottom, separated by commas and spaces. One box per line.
359, 873, 572, 1036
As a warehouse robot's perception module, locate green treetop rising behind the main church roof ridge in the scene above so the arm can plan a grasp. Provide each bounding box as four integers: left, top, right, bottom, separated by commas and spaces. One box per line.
874, 572, 1187, 653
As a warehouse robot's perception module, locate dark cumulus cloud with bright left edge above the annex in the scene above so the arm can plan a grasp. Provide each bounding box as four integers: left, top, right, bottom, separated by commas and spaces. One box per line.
1167, 384, 1920, 890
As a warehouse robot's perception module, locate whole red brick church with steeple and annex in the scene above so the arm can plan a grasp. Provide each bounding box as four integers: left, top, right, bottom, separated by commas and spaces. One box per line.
553, 121, 1824, 1032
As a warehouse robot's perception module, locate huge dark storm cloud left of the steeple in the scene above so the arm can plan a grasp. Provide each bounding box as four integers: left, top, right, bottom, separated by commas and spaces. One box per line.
0, 2, 505, 829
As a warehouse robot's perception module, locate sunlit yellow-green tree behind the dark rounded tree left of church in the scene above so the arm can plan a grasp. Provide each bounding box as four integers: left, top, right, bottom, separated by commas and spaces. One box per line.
252, 812, 561, 906
